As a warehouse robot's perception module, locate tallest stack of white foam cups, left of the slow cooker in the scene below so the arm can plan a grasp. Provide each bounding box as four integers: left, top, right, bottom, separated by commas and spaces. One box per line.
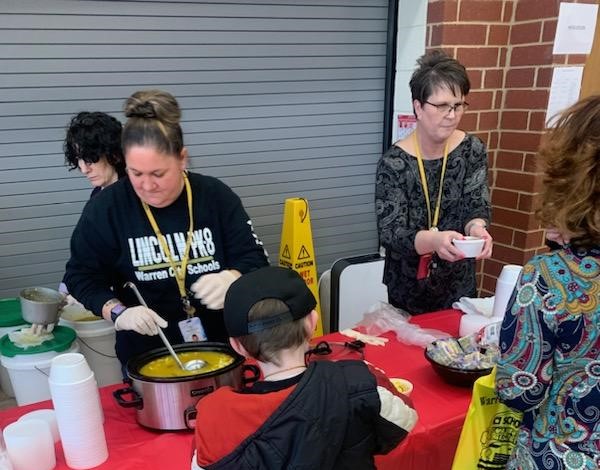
48, 353, 108, 469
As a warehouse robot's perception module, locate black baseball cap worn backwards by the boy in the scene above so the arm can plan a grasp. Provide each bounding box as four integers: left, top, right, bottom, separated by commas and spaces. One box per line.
223, 266, 317, 338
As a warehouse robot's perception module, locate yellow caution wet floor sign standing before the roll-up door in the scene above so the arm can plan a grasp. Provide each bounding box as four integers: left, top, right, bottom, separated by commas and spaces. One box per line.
279, 198, 323, 336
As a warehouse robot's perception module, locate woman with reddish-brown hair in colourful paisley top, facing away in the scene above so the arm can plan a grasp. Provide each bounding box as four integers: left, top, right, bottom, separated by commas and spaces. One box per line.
496, 96, 600, 470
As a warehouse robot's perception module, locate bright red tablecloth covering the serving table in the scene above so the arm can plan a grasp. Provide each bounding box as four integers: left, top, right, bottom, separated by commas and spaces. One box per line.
0, 310, 471, 470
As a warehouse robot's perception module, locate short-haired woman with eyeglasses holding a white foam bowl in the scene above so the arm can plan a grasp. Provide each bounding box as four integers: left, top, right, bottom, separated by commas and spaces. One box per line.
375, 50, 492, 314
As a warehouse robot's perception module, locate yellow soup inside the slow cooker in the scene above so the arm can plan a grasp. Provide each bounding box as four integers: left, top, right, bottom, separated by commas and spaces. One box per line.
140, 351, 234, 379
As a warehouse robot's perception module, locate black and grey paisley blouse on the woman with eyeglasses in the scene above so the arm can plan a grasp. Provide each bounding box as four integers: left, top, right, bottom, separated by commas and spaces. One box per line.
375, 134, 490, 314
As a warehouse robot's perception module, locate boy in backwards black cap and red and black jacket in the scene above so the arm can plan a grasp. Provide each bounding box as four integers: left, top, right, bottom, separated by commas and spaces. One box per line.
191, 267, 417, 470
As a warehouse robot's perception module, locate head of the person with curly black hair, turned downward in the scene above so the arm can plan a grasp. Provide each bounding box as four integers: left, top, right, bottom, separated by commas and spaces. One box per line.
63, 111, 125, 196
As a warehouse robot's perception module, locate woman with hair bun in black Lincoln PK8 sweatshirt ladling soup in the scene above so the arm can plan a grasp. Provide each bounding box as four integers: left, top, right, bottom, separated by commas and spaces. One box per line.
65, 90, 268, 364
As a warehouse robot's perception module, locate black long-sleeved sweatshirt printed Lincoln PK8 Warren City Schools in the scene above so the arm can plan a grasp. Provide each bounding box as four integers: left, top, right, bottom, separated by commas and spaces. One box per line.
65, 173, 268, 363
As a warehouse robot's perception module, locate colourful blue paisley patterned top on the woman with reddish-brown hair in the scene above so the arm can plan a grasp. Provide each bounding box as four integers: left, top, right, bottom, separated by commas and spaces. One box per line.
496, 247, 600, 470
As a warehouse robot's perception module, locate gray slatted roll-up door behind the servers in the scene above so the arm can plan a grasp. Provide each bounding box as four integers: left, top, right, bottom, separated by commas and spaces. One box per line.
0, 0, 388, 297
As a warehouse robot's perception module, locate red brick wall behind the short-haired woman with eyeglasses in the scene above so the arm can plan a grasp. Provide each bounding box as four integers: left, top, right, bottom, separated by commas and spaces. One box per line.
427, 0, 594, 294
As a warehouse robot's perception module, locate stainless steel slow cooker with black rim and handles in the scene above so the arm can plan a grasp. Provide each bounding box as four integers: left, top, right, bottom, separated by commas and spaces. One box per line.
113, 342, 256, 431
